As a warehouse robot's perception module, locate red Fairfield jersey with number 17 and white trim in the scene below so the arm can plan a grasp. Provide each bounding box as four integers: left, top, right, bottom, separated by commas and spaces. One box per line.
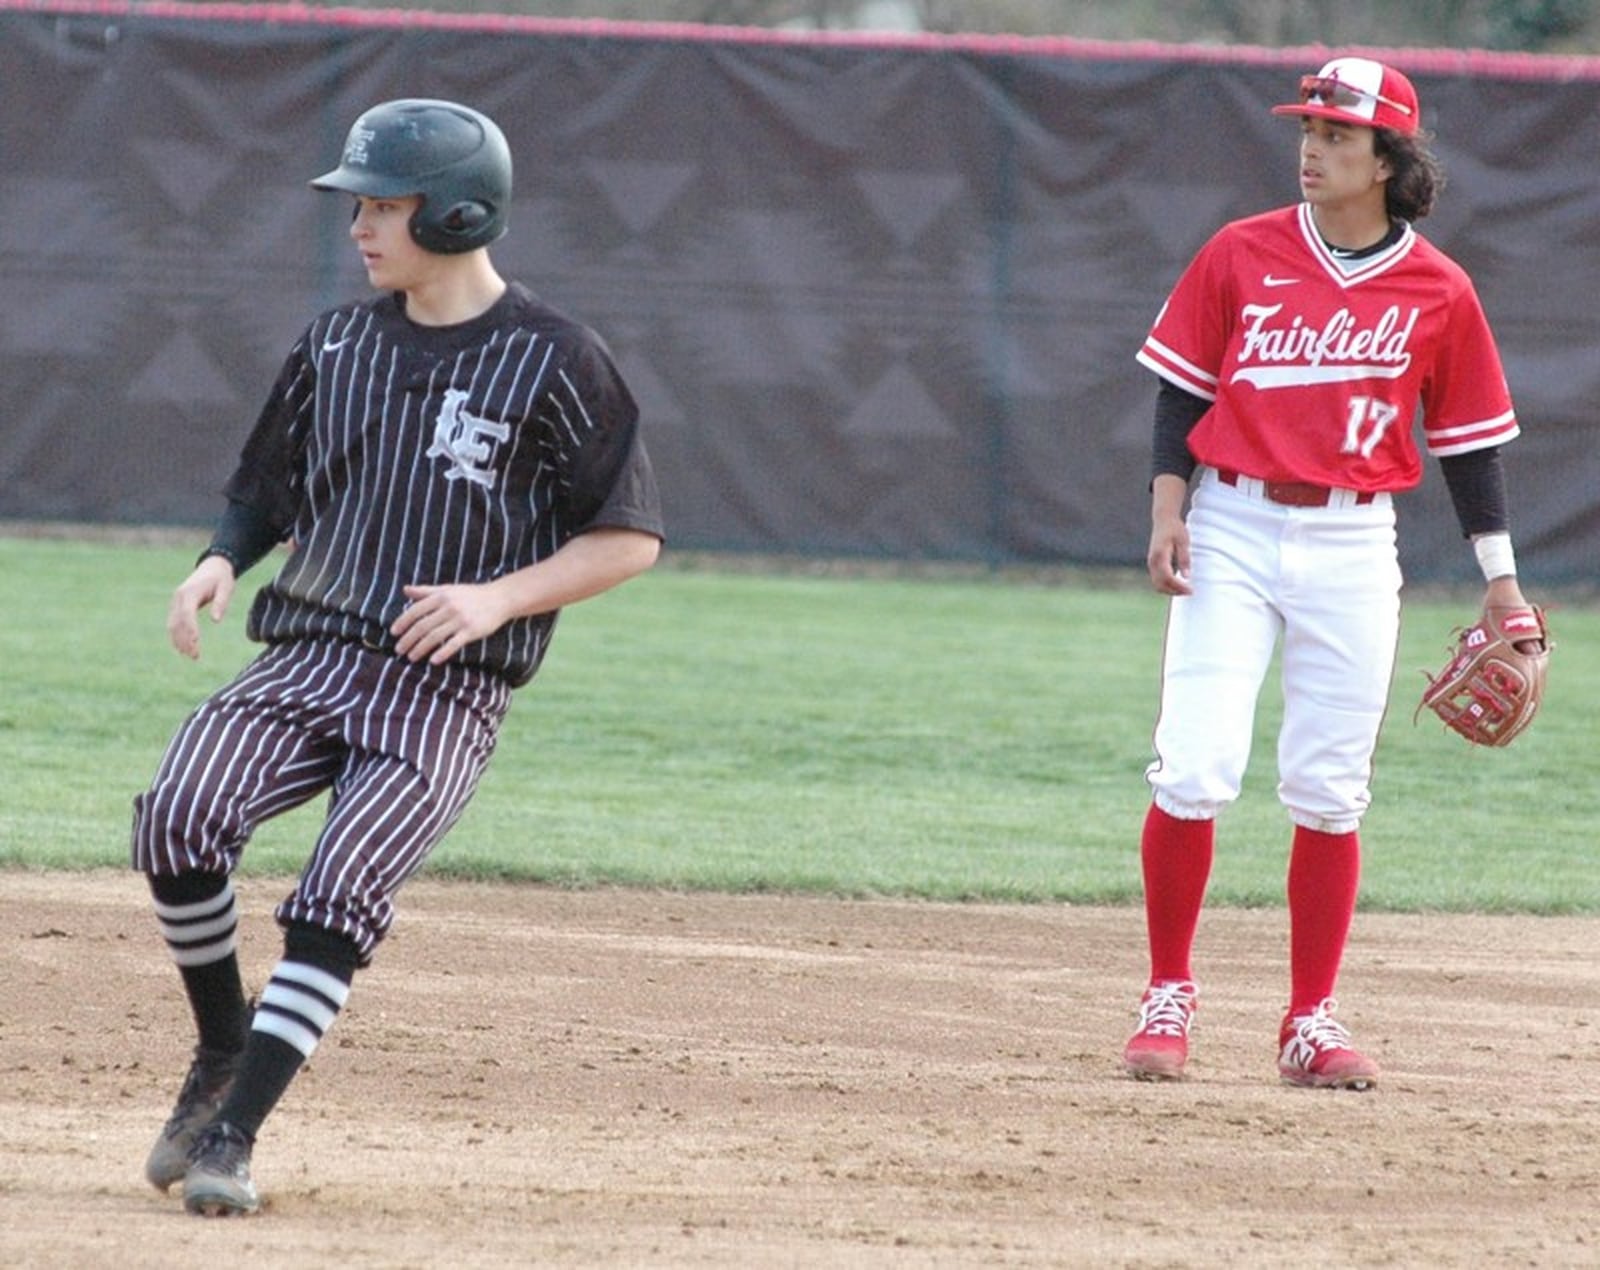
1138, 203, 1518, 491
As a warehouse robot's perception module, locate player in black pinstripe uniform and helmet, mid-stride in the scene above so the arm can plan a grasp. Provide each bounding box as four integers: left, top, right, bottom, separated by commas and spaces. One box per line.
133, 99, 662, 1216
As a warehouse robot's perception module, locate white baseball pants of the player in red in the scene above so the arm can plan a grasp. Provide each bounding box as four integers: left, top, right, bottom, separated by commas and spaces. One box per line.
1147, 469, 1400, 833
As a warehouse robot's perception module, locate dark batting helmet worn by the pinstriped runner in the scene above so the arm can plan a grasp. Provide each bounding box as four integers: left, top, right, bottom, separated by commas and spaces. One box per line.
310, 98, 510, 256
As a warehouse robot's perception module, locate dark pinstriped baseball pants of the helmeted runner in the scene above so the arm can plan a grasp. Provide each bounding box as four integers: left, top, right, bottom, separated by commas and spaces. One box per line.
133, 641, 510, 964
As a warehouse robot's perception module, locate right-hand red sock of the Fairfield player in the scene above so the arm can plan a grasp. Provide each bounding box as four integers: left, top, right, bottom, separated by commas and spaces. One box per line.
1288, 825, 1362, 1014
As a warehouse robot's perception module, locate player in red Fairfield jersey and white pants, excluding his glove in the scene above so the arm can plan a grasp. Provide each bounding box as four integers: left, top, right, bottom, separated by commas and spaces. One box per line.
1123, 58, 1538, 1089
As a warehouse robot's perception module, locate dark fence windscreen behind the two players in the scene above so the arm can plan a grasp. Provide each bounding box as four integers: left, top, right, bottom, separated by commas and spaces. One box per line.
0, 3, 1600, 581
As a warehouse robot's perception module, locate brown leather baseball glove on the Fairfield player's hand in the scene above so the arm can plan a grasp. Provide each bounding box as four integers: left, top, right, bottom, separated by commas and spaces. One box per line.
1413, 606, 1552, 745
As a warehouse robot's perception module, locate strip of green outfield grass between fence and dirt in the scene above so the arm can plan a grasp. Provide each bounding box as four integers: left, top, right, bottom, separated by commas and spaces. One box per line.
0, 537, 1600, 913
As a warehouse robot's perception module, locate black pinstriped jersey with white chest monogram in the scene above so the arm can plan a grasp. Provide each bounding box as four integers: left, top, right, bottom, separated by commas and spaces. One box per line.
227, 283, 662, 685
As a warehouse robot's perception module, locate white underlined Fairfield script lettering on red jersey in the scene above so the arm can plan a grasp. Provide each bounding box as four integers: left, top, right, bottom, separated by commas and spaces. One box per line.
1234, 304, 1421, 389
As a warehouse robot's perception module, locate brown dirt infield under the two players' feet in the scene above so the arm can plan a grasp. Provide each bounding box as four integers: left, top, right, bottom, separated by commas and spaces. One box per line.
0, 873, 1600, 1270
